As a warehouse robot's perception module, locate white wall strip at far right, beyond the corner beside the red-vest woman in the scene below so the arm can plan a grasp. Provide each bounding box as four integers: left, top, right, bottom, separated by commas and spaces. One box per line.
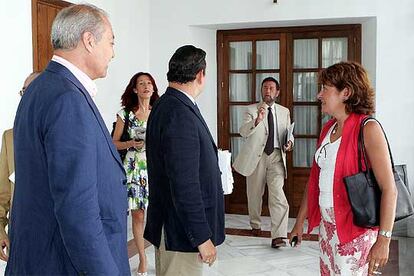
376, 0, 414, 175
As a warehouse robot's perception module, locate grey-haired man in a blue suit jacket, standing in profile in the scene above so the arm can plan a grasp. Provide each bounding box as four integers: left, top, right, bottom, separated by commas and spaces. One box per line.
6, 5, 130, 275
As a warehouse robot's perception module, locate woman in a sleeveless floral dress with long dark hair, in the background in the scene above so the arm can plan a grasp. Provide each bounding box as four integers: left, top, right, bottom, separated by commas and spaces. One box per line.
113, 72, 158, 276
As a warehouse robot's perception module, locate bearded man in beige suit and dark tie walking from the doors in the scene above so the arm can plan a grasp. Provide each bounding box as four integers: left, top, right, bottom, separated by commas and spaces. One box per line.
233, 77, 294, 248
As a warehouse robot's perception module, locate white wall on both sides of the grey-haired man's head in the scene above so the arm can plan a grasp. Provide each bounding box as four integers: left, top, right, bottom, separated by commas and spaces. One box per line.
0, 0, 149, 137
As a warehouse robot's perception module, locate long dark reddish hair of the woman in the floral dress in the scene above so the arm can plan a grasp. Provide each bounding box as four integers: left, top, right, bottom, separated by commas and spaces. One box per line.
121, 72, 159, 112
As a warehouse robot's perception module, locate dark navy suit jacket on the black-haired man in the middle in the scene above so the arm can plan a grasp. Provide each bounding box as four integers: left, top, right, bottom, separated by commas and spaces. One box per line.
144, 87, 225, 252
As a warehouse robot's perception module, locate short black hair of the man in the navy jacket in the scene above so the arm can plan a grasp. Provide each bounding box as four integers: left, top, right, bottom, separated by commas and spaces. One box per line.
167, 45, 206, 83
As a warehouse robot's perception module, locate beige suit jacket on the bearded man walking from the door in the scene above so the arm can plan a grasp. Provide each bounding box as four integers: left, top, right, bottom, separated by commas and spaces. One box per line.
233, 102, 294, 178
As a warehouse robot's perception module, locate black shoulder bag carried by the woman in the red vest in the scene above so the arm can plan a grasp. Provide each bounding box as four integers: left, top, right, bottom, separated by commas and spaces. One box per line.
344, 117, 414, 228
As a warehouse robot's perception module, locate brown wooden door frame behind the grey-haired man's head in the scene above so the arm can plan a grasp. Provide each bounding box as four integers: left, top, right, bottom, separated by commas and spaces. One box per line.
32, 0, 73, 71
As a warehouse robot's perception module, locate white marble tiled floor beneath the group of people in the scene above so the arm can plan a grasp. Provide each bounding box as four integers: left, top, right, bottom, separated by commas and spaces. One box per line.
0, 215, 414, 276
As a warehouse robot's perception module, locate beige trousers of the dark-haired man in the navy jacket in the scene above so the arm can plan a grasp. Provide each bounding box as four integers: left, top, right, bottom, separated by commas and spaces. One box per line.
155, 229, 203, 276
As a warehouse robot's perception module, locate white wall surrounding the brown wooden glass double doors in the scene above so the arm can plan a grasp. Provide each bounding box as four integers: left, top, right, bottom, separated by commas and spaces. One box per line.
150, 0, 414, 181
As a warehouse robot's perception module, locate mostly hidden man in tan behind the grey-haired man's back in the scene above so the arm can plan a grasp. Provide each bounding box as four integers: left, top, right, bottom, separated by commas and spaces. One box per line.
0, 72, 40, 262
